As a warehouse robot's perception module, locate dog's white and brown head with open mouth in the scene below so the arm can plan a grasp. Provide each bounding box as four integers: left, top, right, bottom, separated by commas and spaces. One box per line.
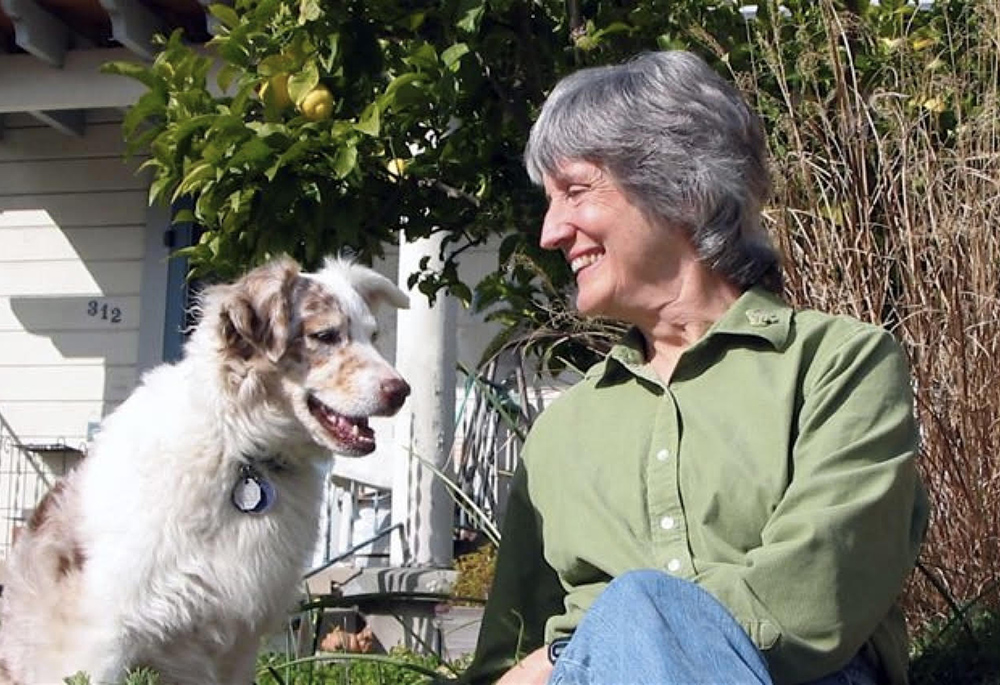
211, 254, 410, 456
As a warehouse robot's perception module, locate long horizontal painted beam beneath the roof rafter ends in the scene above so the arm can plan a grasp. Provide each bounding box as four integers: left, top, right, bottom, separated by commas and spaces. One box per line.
0, 48, 146, 114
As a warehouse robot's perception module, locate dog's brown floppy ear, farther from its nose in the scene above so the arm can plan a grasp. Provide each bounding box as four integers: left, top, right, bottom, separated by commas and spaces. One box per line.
219, 257, 299, 363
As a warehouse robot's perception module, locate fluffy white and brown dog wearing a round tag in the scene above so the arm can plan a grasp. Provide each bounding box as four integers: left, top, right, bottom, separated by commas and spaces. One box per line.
0, 258, 410, 685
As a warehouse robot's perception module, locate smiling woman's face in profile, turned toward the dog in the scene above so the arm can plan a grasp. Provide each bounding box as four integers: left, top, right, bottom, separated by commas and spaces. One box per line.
541, 160, 697, 325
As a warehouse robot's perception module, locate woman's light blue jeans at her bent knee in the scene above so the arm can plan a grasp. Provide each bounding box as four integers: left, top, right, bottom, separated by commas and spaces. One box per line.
549, 571, 877, 685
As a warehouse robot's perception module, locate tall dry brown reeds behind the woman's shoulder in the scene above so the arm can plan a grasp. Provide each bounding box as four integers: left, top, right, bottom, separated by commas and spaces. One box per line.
751, 0, 1000, 632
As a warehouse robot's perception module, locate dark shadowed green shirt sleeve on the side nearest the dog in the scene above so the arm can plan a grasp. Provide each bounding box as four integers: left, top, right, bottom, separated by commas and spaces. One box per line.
442, 462, 565, 684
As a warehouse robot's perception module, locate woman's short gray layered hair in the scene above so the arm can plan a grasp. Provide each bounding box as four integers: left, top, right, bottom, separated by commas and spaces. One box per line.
525, 50, 782, 293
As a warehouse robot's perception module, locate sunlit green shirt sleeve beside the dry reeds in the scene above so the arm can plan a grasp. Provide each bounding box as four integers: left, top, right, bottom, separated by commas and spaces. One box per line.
695, 326, 927, 683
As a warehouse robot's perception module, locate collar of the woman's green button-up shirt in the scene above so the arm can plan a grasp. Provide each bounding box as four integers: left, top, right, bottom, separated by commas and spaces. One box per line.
587, 286, 793, 380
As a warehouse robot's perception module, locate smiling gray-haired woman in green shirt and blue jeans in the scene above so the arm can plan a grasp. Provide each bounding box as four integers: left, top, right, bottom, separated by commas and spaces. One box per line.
465, 52, 927, 685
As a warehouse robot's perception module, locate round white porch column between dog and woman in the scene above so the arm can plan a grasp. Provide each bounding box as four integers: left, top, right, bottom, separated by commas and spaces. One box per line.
390, 234, 457, 568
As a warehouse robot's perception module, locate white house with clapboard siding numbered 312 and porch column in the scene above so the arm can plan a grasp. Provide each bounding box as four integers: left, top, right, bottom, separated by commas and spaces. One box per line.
0, 0, 516, 584
